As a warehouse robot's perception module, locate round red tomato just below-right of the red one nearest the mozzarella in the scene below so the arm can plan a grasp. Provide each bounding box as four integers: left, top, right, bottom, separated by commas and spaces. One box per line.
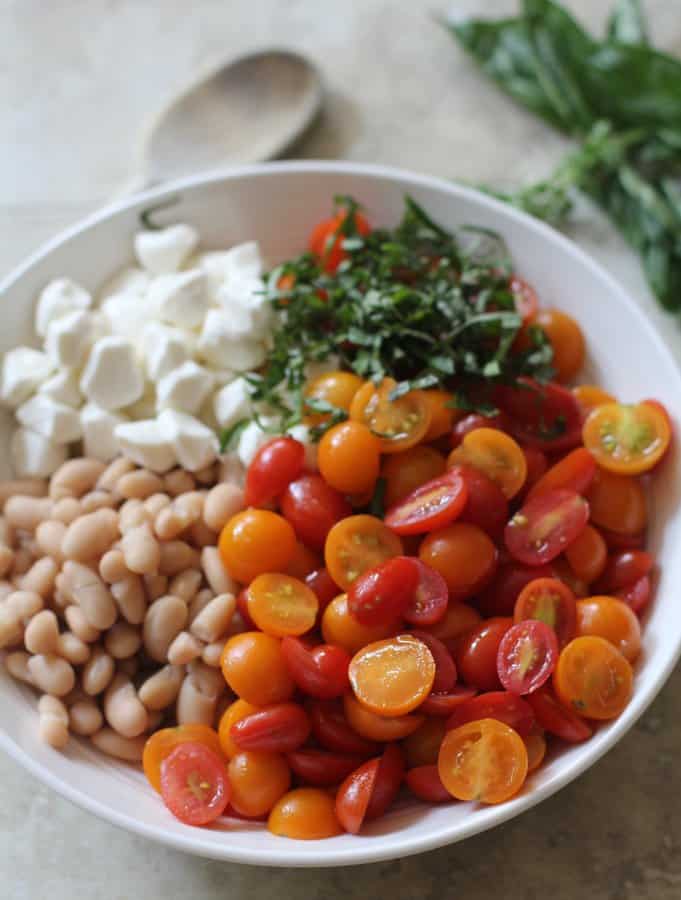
281, 475, 352, 550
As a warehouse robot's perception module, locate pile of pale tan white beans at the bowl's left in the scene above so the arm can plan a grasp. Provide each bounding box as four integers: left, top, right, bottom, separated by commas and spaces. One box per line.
0, 457, 244, 761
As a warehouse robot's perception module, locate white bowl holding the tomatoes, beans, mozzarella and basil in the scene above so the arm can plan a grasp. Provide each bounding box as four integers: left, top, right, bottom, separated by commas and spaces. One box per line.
0, 162, 681, 866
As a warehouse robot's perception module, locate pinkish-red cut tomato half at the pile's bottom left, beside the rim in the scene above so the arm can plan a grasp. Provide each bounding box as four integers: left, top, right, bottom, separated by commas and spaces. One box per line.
161, 741, 230, 825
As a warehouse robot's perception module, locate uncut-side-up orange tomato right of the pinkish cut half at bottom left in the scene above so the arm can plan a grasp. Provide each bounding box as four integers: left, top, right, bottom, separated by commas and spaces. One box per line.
227, 750, 291, 818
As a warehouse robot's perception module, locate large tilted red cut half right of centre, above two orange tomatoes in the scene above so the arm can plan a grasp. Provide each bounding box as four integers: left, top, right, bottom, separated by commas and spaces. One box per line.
504, 490, 589, 566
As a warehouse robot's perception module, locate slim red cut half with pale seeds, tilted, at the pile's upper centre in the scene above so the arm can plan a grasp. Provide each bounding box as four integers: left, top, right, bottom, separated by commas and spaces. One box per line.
385, 469, 468, 534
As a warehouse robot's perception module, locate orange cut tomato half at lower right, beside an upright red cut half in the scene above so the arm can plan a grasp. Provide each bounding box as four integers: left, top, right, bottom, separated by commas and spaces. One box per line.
553, 635, 634, 719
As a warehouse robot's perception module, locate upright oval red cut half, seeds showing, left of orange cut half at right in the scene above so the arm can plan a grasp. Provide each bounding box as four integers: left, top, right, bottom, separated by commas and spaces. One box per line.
497, 619, 558, 694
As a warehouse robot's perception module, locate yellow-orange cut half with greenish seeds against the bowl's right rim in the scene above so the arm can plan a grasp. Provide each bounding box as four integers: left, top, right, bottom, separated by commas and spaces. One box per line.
582, 403, 671, 475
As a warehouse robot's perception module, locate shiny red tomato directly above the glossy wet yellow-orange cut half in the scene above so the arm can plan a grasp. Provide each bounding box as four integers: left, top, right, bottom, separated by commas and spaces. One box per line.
348, 556, 421, 626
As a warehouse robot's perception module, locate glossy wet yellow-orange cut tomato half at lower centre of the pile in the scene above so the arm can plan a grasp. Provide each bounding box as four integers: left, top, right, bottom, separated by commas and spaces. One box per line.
348, 634, 435, 716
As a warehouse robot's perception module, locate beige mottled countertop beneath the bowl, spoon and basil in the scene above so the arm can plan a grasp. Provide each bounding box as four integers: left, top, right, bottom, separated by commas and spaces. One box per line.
0, 0, 681, 900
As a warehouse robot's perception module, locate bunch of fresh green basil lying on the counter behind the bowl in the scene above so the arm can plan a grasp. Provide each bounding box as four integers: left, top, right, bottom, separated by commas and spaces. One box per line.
445, 0, 681, 310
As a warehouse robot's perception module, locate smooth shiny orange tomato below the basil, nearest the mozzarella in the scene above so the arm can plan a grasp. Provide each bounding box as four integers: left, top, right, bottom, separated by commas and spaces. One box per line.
317, 422, 381, 494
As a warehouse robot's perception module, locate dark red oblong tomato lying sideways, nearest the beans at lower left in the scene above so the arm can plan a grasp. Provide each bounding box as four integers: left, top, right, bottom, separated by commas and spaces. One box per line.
229, 703, 310, 753
